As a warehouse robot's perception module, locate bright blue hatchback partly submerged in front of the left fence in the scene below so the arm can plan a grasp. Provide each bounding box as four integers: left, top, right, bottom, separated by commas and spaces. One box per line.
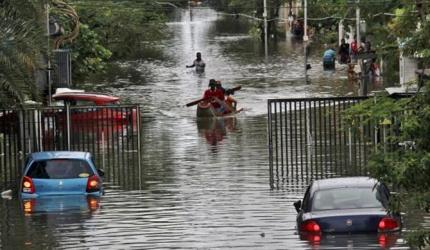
20, 151, 104, 199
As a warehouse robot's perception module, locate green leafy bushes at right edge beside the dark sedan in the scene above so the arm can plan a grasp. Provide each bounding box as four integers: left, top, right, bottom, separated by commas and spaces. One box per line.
345, 85, 430, 247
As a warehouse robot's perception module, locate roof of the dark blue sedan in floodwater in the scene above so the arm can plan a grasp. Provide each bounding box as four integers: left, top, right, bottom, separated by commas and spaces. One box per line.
312, 176, 378, 192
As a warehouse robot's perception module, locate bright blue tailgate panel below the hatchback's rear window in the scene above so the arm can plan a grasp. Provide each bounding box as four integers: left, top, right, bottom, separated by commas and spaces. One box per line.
33, 178, 88, 195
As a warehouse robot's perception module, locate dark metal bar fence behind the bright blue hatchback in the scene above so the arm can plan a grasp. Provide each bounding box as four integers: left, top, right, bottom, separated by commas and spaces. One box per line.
0, 105, 141, 188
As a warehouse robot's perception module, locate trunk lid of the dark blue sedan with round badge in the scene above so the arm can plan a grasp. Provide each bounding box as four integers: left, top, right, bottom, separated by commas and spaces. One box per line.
310, 208, 387, 233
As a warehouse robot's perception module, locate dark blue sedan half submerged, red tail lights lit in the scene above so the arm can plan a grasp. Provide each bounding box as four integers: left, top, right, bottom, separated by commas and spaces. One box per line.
294, 177, 401, 238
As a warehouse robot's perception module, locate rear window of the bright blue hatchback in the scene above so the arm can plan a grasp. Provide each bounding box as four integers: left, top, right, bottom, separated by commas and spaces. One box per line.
27, 159, 94, 179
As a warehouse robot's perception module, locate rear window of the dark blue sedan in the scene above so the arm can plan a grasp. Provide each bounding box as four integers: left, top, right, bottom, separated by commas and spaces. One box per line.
312, 188, 386, 211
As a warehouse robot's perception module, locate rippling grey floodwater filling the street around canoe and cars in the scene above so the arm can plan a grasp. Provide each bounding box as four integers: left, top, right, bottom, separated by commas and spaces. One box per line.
0, 6, 406, 249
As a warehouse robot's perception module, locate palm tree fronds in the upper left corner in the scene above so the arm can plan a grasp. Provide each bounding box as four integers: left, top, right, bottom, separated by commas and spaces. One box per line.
0, 0, 44, 107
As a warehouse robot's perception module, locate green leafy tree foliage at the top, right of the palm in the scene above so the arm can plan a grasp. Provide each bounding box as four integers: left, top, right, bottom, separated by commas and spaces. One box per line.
73, 0, 166, 60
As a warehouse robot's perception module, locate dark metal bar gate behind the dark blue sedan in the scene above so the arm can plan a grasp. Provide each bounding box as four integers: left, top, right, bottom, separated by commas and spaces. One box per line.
268, 97, 381, 180
